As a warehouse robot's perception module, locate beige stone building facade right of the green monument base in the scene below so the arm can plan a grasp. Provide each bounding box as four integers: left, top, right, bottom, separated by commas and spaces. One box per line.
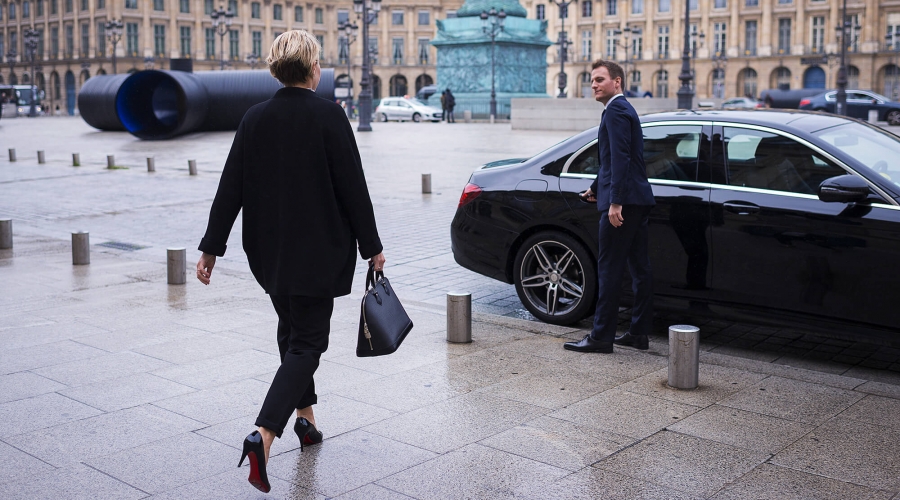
524, 0, 900, 102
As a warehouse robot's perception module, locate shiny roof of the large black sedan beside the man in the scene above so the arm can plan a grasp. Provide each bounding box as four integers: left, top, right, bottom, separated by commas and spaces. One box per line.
641, 109, 853, 133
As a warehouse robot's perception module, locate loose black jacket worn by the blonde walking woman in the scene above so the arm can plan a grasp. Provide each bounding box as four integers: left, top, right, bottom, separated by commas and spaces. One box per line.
200, 87, 382, 297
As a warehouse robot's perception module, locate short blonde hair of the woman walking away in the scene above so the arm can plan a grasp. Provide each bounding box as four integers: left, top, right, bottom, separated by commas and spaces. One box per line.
266, 30, 322, 85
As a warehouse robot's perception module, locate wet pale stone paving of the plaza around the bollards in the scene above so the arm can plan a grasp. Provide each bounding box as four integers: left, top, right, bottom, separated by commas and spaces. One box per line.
0, 118, 900, 500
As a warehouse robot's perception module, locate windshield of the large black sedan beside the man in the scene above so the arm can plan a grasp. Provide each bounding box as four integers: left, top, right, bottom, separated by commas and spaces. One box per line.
813, 123, 900, 186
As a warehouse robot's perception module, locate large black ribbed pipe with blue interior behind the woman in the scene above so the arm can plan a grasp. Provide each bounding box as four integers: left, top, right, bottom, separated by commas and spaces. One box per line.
78, 68, 334, 140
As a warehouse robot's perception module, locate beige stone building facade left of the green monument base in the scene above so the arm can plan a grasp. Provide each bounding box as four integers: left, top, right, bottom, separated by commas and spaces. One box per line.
0, 0, 462, 113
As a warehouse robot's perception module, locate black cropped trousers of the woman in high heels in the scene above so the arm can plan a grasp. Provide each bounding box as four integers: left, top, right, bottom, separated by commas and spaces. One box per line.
256, 295, 334, 437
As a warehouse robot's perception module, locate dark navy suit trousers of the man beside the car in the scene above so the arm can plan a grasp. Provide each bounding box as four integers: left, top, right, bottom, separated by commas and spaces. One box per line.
591, 205, 653, 342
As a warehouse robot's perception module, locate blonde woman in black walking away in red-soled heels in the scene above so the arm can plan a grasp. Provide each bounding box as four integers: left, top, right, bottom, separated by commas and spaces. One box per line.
197, 30, 385, 492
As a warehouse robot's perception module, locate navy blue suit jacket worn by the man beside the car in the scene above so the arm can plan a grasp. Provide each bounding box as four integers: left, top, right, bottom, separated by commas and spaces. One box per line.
591, 96, 656, 212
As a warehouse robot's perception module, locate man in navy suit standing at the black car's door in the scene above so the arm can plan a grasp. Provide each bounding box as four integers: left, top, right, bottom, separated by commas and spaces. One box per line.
564, 60, 656, 353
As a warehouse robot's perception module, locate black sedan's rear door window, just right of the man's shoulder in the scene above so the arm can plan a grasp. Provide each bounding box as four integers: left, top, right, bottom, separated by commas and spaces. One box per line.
644, 125, 703, 181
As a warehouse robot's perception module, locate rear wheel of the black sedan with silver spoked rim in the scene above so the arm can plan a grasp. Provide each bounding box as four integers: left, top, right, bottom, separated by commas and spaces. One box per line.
513, 231, 597, 325
